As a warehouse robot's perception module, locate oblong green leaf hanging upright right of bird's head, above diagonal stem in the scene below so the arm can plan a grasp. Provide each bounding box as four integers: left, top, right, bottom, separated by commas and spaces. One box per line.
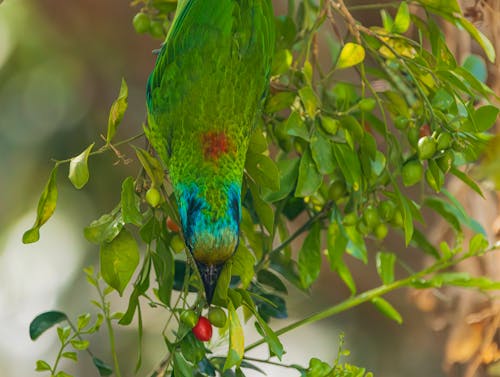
298, 222, 321, 289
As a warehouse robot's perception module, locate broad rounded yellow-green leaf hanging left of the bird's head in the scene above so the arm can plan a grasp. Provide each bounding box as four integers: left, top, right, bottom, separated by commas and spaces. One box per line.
100, 228, 139, 296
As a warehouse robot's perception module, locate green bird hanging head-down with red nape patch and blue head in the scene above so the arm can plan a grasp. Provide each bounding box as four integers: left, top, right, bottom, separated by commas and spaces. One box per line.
146, 0, 275, 303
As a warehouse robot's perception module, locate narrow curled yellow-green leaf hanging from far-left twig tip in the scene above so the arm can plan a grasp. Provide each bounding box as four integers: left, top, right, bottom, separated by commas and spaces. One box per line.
23, 165, 58, 243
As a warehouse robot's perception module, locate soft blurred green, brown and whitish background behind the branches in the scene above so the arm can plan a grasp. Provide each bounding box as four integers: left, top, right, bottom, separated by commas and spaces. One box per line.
0, 0, 476, 377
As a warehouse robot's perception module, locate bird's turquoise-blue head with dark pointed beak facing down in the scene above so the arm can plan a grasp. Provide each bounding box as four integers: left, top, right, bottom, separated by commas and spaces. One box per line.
178, 182, 241, 303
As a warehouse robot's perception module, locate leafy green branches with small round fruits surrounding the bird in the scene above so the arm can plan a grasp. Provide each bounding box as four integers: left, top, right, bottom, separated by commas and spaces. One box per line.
23, 0, 499, 377
